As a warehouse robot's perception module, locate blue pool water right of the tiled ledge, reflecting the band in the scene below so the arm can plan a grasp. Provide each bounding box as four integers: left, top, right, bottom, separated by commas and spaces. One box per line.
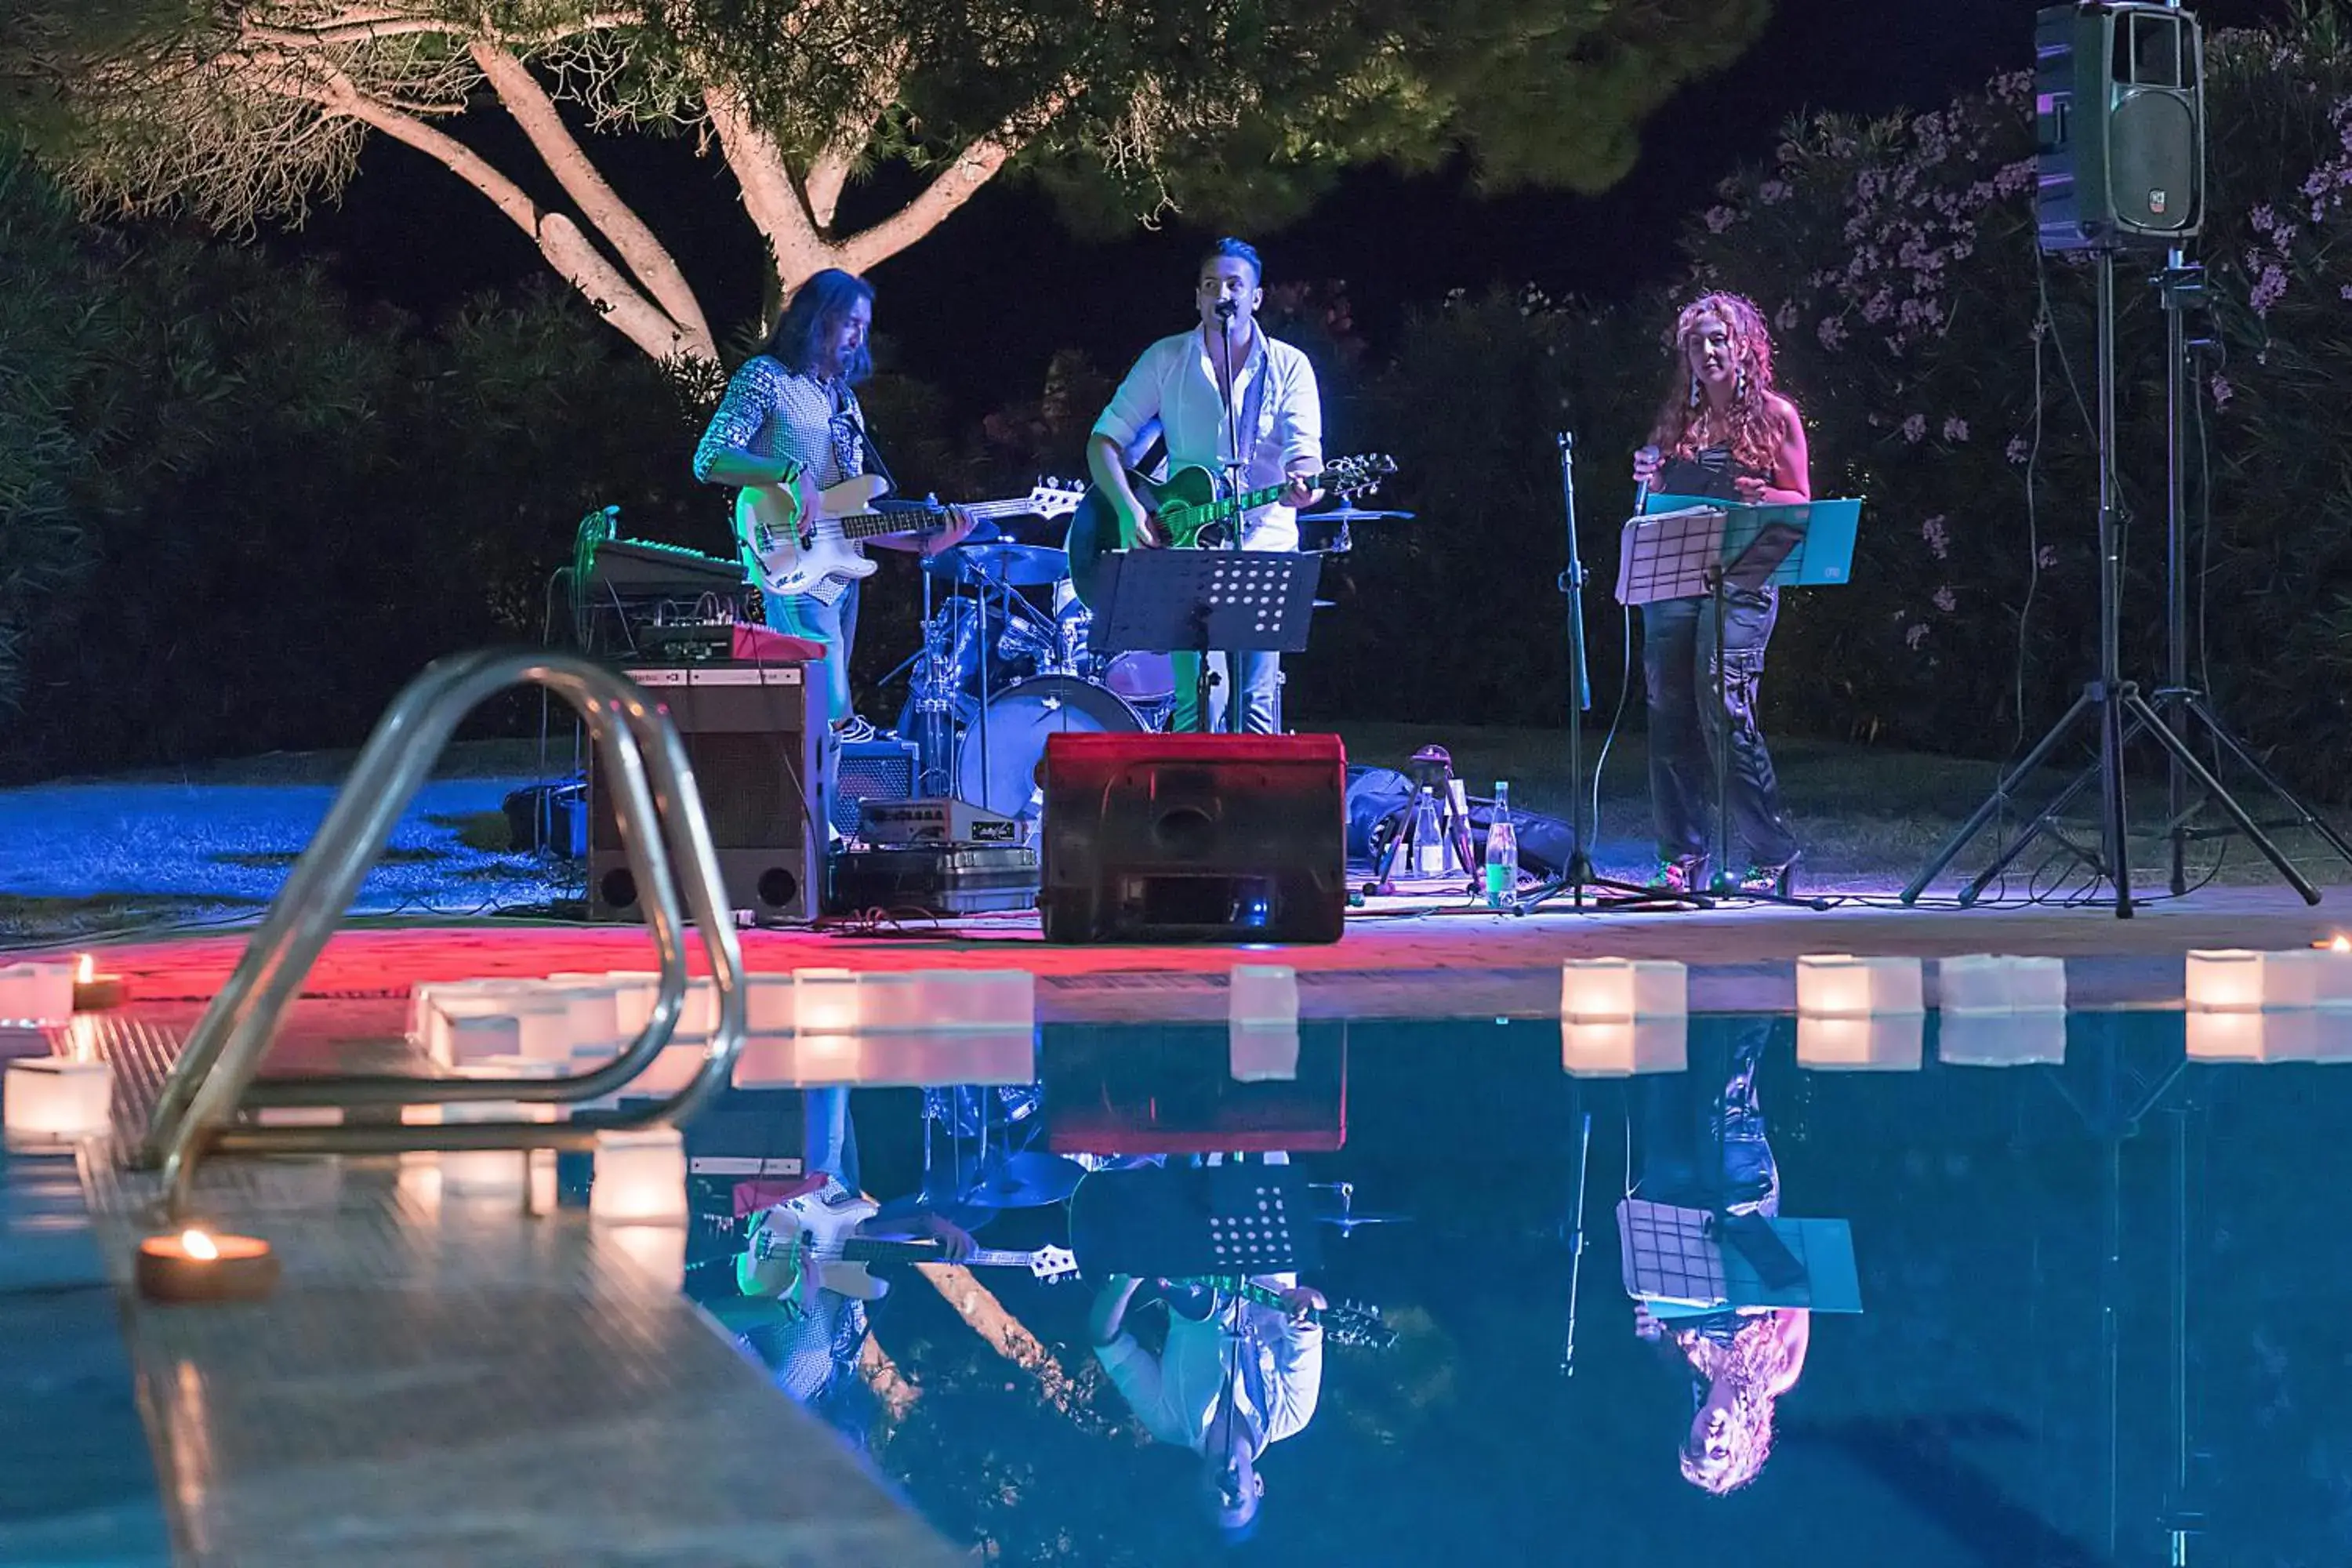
663, 1011, 2352, 1568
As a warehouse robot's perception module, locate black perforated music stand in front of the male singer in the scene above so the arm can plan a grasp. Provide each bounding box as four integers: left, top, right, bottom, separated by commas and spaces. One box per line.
1087, 550, 1322, 734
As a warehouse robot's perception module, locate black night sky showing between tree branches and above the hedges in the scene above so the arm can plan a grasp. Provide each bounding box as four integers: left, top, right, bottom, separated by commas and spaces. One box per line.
289, 0, 2284, 416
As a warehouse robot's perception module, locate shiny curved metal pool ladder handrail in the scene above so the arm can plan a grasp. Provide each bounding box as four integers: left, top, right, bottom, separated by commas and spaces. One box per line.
139, 649, 746, 1215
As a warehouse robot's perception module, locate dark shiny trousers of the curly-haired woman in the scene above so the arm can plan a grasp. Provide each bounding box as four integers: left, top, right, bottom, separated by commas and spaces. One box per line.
1642, 588, 1797, 869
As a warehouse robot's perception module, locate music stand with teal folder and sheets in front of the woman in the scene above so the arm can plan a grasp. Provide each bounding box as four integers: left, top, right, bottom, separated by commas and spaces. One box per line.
1616, 496, 1860, 909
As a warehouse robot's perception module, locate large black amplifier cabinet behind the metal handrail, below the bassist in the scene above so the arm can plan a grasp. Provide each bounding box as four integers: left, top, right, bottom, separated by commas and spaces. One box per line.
588, 663, 826, 924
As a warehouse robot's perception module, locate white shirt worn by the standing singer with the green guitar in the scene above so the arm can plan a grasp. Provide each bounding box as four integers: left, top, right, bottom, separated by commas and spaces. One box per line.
1094, 327, 1322, 550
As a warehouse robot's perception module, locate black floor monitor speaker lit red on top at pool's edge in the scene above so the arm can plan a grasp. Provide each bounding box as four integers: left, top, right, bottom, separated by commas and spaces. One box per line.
1037, 731, 1348, 942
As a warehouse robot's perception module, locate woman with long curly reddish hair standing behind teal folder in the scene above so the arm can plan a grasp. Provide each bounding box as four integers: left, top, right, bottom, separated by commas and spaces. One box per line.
1632, 294, 1813, 891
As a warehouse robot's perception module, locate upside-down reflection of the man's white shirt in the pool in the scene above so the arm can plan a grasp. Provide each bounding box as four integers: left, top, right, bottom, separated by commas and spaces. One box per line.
1094, 1274, 1322, 1453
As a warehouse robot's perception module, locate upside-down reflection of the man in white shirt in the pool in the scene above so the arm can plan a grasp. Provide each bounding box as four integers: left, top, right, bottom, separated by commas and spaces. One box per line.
1089, 1274, 1324, 1542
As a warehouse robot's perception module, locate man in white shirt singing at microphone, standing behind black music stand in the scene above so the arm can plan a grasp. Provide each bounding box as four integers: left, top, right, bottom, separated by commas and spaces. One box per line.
1087, 240, 1322, 736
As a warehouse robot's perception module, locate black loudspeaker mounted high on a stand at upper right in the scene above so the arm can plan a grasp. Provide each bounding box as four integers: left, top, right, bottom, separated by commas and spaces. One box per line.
2034, 2, 2204, 252
